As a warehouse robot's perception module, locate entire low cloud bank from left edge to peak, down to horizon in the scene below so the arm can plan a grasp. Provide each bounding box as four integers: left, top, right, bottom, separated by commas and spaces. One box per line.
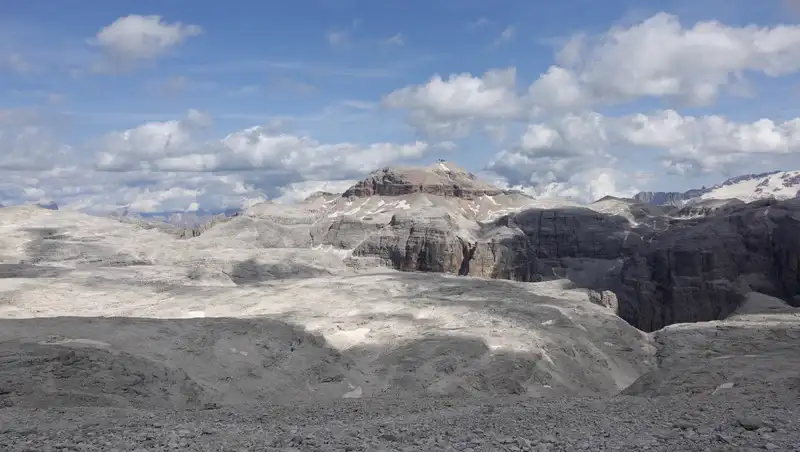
0, 105, 438, 213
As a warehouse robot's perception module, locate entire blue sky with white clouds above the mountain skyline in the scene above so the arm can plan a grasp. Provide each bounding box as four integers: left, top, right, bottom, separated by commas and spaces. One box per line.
0, 0, 800, 213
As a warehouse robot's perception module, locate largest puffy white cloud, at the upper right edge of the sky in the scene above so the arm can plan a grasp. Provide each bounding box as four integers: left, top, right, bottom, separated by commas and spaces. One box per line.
529, 13, 800, 108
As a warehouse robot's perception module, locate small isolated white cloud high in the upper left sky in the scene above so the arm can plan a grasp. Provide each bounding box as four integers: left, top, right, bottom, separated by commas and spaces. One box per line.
90, 14, 203, 63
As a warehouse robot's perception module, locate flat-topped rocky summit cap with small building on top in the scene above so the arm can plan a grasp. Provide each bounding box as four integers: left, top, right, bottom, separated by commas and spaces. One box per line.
342, 160, 504, 199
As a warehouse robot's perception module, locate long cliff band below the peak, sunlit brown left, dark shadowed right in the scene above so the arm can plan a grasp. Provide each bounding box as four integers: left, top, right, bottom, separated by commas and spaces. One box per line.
354, 196, 800, 331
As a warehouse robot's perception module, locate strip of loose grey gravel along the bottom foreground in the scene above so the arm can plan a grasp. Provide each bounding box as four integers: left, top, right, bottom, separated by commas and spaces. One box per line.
0, 389, 800, 452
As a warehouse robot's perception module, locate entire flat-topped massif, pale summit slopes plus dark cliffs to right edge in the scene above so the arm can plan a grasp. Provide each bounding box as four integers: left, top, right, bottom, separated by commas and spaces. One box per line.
184, 162, 800, 331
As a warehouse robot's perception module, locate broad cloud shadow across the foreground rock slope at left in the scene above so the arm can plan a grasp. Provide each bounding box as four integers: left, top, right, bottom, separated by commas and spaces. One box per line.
0, 317, 632, 409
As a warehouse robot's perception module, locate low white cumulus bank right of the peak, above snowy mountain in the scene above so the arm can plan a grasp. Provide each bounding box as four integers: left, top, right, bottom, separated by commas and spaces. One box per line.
486, 110, 800, 194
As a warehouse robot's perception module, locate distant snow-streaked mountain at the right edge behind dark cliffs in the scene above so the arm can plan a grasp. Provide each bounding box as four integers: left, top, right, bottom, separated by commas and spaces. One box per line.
633, 171, 800, 207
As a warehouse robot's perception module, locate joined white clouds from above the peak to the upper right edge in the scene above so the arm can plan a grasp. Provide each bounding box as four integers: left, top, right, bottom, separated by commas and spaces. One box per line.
384, 13, 800, 136
